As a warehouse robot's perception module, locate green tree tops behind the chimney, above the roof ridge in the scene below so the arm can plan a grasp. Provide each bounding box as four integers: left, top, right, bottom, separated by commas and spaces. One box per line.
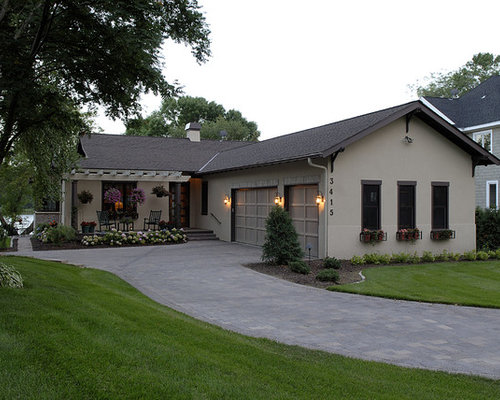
125, 96, 260, 141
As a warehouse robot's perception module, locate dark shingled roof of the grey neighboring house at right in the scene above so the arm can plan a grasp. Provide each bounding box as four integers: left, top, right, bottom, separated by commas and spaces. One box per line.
424, 76, 500, 128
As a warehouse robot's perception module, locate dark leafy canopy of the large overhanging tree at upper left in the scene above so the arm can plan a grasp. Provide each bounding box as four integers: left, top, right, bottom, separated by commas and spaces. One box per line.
0, 0, 210, 178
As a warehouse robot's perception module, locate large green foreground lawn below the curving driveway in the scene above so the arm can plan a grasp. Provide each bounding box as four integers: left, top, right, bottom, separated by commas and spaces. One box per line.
0, 257, 500, 400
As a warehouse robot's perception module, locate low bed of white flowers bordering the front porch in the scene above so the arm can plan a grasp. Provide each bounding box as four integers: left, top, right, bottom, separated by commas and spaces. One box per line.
81, 228, 187, 246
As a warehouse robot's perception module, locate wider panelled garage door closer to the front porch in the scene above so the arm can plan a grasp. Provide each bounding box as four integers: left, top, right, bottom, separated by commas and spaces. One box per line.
234, 188, 277, 246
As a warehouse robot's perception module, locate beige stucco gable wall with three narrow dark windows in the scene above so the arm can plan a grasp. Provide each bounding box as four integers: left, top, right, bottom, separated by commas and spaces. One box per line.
328, 118, 475, 258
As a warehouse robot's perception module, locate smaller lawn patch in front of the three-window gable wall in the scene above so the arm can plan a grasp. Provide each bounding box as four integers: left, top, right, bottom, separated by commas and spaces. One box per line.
329, 260, 500, 308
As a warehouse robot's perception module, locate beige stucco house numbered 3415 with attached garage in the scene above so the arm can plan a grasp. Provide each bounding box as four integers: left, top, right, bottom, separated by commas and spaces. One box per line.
63, 101, 500, 258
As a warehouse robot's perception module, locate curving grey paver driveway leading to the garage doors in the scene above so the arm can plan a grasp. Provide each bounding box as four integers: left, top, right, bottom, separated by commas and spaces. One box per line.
13, 241, 500, 379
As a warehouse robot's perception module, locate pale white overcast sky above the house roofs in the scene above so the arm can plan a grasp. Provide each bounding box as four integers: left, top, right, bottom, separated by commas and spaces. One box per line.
97, 0, 500, 140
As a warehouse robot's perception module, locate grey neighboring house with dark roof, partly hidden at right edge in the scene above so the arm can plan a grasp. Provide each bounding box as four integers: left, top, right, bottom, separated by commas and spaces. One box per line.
421, 76, 500, 209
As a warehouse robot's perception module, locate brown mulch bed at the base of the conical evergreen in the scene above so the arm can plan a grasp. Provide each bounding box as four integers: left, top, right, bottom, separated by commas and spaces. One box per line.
245, 260, 380, 289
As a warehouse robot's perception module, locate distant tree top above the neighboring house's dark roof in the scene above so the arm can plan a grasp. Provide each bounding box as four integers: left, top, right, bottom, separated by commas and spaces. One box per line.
410, 53, 500, 98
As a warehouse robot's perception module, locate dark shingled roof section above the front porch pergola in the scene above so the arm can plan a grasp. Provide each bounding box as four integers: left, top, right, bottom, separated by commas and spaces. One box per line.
80, 134, 249, 172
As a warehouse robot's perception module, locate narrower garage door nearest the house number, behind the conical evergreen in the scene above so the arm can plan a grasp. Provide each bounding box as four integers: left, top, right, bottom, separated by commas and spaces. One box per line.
288, 185, 319, 257
